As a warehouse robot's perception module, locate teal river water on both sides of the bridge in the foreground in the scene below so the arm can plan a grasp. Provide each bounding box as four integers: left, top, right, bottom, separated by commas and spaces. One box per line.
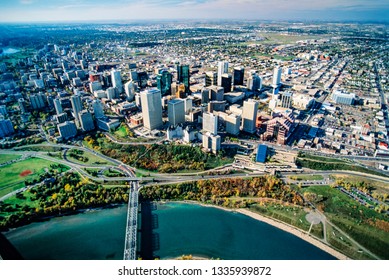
5, 203, 334, 260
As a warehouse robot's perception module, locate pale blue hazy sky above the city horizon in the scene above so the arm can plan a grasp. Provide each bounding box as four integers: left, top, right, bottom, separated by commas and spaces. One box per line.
0, 0, 389, 22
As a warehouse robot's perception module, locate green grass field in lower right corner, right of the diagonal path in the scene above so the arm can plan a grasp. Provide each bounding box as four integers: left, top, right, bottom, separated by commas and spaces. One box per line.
303, 186, 389, 259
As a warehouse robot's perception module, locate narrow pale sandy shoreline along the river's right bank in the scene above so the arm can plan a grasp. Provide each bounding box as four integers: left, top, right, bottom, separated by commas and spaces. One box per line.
177, 201, 350, 260
